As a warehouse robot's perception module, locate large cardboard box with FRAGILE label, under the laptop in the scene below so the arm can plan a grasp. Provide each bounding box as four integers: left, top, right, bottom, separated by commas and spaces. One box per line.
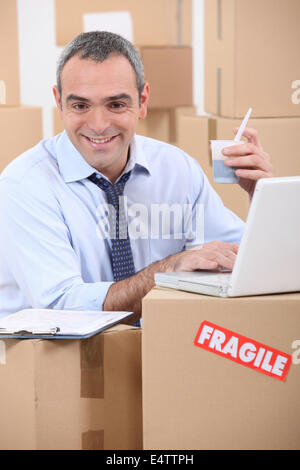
142, 289, 300, 450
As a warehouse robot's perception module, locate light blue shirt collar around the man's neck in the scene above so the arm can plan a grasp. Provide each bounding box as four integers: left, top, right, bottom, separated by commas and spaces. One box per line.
56, 131, 150, 183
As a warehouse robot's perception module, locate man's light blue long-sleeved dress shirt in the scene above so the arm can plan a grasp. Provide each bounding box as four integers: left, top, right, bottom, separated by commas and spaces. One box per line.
0, 132, 244, 317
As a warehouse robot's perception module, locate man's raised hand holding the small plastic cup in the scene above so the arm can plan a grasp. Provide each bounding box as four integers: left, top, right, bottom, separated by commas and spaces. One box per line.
222, 127, 273, 199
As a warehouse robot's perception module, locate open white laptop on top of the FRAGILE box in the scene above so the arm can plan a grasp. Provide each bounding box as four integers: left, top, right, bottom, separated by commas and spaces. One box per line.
155, 176, 300, 297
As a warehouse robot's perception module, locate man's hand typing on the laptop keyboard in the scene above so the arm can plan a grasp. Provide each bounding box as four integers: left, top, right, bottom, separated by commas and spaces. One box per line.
171, 241, 239, 272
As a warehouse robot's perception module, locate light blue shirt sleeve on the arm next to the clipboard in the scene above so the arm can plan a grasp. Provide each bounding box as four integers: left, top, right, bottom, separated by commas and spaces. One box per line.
0, 178, 112, 310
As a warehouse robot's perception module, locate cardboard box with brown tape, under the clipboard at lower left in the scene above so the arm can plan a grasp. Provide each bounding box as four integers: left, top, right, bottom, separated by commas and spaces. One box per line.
0, 325, 142, 450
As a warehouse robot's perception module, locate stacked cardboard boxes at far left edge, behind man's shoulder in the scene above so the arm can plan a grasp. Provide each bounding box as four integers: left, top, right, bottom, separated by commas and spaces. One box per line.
0, 0, 42, 172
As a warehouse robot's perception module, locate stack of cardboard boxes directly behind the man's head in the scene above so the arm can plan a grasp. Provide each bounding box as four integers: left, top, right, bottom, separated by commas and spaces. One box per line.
54, 0, 195, 143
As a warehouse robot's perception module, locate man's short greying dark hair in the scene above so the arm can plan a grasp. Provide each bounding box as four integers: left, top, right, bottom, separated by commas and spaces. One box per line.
56, 31, 144, 98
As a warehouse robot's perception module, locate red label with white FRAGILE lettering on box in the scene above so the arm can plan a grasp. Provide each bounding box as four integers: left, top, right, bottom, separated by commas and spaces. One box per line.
194, 321, 292, 380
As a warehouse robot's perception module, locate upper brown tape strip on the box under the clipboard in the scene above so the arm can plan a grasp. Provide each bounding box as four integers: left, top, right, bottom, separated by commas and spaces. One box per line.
80, 335, 104, 398
